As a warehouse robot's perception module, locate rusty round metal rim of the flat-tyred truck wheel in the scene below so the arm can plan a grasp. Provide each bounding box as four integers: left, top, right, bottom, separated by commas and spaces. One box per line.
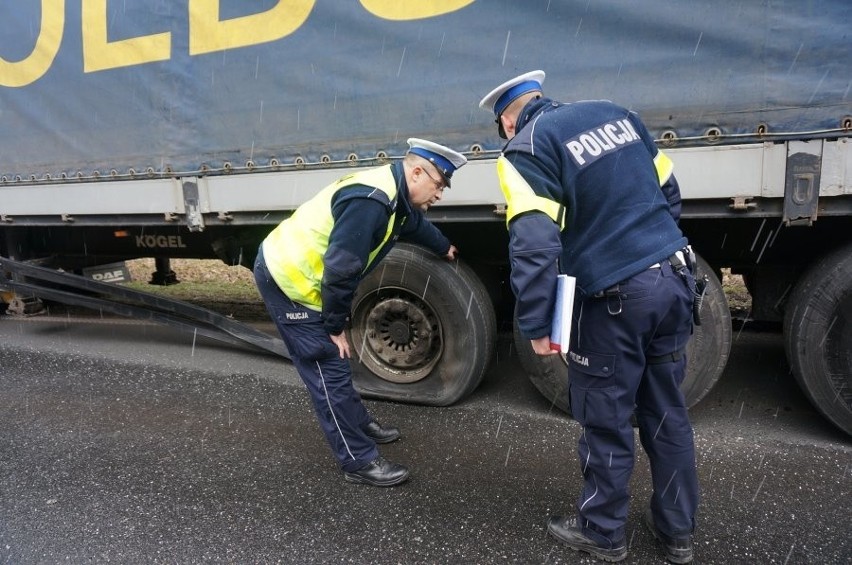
351, 287, 444, 383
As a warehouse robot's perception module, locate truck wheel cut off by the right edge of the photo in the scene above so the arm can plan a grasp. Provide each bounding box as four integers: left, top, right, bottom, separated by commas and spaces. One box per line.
784, 245, 852, 435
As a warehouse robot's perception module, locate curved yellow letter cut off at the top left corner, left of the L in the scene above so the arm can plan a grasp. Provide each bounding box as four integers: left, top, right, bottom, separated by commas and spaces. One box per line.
0, 0, 65, 87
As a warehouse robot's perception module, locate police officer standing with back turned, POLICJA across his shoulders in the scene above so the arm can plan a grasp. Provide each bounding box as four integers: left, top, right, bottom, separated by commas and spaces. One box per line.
480, 71, 698, 563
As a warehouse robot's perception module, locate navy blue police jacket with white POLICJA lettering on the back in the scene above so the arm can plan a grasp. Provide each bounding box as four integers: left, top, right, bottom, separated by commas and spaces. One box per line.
503, 97, 687, 339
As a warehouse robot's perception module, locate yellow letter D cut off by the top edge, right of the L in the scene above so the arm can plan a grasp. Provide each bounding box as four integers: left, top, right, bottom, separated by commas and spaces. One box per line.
189, 0, 316, 55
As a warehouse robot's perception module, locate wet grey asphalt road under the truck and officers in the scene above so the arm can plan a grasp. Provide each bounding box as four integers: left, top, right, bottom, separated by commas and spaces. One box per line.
0, 317, 852, 564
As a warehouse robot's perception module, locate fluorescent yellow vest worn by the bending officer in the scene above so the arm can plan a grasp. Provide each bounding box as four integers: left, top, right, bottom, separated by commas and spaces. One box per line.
263, 165, 397, 311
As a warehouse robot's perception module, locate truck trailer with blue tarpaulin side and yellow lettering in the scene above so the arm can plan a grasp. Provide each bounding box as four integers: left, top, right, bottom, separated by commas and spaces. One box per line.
0, 0, 852, 434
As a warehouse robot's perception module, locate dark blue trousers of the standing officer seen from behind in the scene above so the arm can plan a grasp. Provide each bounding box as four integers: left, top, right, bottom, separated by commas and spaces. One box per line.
569, 261, 698, 546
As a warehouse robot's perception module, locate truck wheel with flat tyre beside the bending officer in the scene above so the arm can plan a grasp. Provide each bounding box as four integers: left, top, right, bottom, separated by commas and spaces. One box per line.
349, 244, 497, 406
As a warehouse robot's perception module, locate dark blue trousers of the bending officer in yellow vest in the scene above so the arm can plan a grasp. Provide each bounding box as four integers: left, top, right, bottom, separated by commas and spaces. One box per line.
254, 249, 379, 471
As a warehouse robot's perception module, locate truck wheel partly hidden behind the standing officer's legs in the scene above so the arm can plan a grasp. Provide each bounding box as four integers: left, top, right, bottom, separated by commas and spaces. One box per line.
514, 252, 731, 415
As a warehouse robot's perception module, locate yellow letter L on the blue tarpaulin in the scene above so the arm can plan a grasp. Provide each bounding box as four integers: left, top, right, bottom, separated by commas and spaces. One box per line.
82, 0, 172, 73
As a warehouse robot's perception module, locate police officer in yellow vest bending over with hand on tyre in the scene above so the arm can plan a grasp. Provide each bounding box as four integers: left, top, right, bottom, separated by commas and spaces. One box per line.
254, 138, 467, 487
